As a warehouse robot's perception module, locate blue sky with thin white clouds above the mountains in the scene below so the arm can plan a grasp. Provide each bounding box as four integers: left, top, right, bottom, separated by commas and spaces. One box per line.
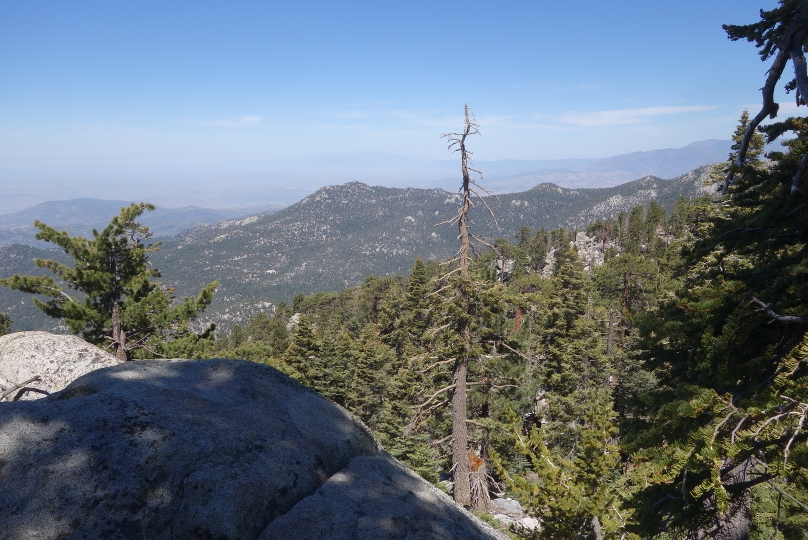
0, 0, 793, 207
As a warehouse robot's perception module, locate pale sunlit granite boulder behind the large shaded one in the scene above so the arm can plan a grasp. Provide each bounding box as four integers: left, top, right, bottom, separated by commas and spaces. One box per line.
0, 332, 120, 401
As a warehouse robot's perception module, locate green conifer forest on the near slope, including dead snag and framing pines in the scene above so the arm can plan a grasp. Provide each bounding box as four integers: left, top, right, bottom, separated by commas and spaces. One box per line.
0, 0, 808, 540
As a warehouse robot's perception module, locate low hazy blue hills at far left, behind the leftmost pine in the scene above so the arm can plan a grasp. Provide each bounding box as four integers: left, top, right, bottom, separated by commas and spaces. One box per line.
0, 199, 281, 248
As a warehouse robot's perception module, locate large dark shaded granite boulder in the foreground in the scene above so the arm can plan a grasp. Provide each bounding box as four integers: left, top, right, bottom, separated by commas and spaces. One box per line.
0, 360, 502, 540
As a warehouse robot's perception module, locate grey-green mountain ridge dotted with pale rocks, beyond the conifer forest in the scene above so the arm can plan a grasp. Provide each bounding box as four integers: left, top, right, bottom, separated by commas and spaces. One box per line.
0, 166, 714, 329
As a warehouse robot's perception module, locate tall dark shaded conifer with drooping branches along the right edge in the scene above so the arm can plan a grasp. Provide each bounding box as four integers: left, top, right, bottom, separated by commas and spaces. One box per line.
626, 5, 808, 539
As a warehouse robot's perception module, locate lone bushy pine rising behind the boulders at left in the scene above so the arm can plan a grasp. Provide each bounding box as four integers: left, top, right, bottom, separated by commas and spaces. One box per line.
0, 203, 218, 360
